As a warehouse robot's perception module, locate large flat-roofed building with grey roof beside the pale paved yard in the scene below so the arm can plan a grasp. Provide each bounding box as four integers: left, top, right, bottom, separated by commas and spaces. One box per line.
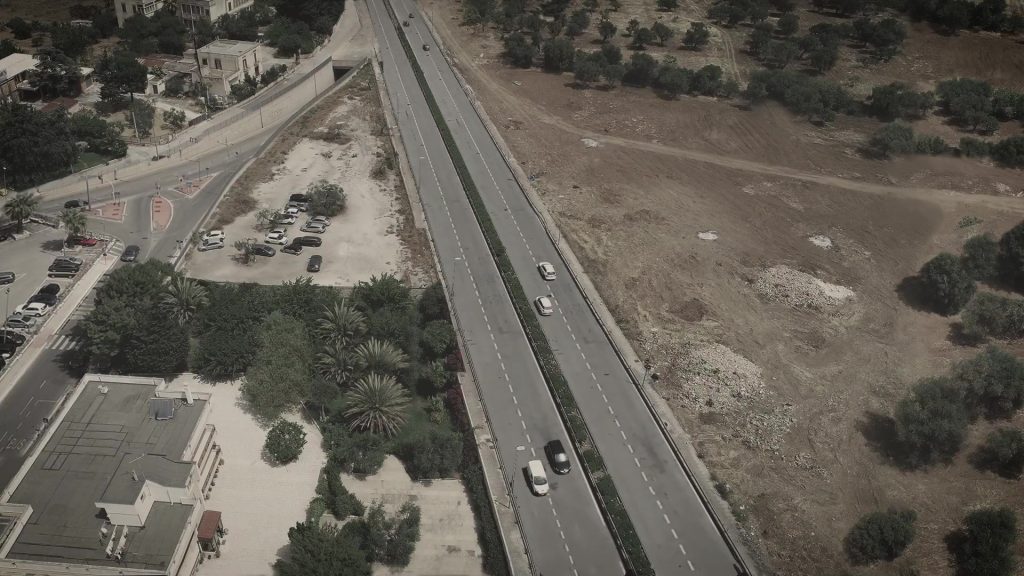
0, 374, 221, 576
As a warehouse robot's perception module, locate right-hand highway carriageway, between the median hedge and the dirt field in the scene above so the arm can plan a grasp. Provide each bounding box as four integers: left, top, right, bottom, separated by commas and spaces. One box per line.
389, 0, 738, 576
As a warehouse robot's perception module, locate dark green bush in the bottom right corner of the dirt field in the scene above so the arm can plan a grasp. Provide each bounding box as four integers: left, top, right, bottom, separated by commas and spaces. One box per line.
949, 507, 1017, 576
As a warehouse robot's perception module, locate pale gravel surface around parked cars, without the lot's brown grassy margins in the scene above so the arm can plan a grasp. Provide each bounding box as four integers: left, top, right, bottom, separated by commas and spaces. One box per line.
185, 93, 410, 286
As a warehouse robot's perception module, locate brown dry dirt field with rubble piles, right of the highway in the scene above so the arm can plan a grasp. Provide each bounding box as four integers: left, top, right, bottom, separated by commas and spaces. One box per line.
425, 0, 1024, 576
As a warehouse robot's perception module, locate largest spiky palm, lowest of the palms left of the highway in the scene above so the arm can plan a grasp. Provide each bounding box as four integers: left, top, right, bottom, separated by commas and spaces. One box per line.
344, 374, 409, 436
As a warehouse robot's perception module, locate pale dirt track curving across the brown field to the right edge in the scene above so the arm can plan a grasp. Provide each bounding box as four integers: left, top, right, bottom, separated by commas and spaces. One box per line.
433, 8, 1024, 213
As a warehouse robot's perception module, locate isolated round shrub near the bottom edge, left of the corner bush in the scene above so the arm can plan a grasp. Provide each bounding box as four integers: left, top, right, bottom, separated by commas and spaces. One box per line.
843, 509, 918, 565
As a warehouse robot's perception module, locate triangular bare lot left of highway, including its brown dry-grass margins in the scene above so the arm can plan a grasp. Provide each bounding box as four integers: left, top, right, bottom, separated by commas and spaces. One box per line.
186, 69, 433, 286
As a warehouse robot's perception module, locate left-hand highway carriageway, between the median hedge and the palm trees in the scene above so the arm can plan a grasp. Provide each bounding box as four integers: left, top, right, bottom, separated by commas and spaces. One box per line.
368, 2, 624, 576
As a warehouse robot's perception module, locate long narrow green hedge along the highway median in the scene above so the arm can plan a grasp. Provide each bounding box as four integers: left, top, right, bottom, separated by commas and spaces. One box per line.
385, 2, 654, 576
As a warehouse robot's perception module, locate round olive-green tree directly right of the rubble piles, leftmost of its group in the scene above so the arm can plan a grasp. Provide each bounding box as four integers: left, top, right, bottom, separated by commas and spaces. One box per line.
895, 378, 970, 466
